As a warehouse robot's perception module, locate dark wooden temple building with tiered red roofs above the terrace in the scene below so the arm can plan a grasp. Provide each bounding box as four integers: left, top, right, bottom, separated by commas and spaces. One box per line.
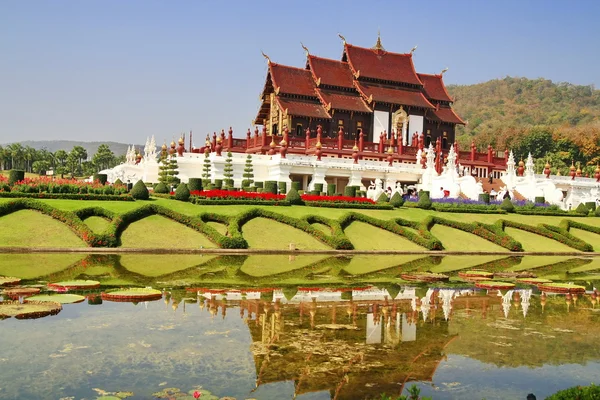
254, 36, 464, 150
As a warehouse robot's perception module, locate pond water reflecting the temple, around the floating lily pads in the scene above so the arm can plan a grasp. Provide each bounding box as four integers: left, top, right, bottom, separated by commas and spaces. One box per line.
0, 254, 600, 400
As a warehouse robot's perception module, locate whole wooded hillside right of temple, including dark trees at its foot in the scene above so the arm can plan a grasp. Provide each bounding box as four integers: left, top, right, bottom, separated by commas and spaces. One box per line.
448, 77, 600, 166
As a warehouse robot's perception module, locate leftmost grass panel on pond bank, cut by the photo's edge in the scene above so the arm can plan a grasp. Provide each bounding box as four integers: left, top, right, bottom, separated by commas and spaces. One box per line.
0, 210, 86, 248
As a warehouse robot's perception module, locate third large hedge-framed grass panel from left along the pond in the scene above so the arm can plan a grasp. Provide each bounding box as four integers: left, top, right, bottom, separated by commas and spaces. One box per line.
242, 218, 330, 250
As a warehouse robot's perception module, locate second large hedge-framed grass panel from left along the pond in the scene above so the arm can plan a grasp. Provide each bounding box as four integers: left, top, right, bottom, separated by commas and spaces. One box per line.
121, 215, 217, 249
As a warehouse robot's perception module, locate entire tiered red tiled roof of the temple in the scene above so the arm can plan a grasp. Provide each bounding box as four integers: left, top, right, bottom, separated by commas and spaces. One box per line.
257, 39, 464, 124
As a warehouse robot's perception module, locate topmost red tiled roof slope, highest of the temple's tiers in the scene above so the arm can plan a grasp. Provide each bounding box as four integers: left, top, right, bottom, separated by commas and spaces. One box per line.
344, 44, 422, 86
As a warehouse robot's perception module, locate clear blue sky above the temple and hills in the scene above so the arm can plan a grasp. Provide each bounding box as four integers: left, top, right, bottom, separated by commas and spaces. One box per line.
0, 0, 600, 145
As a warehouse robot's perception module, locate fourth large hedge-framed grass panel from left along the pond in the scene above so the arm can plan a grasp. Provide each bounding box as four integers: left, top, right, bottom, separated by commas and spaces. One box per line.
344, 221, 426, 251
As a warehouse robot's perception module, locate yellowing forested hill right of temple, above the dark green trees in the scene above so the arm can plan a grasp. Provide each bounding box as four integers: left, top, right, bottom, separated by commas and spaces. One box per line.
448, 77, 600, 145
